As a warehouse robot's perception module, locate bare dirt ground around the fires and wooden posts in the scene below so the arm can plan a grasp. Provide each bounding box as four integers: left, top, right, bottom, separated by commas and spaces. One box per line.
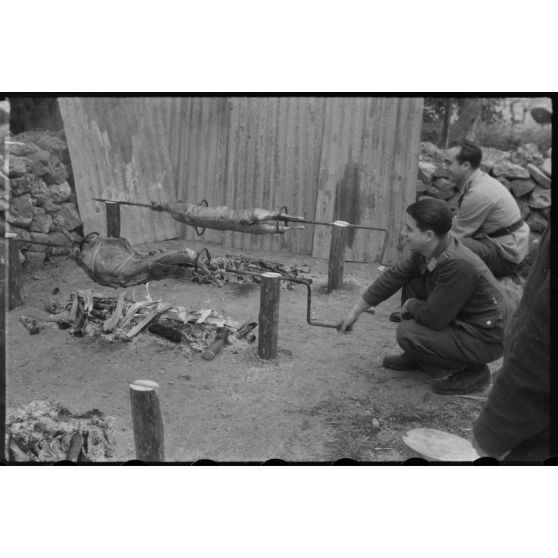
7, 240, 500, 462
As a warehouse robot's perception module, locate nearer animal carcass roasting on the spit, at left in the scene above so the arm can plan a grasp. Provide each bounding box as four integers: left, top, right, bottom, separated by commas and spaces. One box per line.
72, 233, 220, 287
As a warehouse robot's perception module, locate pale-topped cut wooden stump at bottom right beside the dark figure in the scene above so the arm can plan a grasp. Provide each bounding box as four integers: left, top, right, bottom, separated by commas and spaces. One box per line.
401, 428, 480, 461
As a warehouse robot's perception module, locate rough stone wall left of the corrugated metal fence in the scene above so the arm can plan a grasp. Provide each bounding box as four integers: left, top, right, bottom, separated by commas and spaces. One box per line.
6, 131, 83, 269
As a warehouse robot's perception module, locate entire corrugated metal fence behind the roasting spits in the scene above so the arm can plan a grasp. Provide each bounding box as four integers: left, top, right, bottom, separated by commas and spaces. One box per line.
60, 97, 422, 261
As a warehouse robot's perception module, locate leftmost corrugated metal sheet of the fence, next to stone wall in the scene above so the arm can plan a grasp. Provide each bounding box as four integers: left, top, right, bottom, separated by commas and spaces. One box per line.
59, 97, 180, 244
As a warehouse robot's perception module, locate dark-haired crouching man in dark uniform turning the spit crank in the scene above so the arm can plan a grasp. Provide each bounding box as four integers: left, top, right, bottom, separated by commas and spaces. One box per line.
338, 199, 508, 395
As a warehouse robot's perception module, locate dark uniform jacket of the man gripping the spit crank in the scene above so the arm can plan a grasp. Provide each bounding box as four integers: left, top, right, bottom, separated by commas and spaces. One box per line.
362, 232, 508, 343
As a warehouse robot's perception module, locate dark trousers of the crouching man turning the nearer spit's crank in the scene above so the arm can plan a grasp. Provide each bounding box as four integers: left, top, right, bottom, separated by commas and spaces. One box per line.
396, 320, 503, 376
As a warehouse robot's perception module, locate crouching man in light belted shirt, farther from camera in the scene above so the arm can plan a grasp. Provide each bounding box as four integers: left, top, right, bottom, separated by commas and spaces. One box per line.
446, 141, 530, 278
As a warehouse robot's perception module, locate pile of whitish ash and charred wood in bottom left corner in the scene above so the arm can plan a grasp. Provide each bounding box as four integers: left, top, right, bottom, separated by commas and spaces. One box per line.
6, 400, 115, 462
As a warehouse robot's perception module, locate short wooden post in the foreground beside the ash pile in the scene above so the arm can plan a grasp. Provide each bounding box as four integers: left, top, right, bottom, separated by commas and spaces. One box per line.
130, 380, 165, 462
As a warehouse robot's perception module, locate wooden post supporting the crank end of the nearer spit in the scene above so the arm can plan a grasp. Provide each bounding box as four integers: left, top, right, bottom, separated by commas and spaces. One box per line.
258, 273, 281, 360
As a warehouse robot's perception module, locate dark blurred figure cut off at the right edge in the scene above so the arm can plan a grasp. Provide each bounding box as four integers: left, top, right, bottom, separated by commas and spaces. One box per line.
473, 225, 550, 463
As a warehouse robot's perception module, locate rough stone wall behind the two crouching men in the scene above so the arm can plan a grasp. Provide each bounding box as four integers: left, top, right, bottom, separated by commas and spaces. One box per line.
417, 142, 552, 254
